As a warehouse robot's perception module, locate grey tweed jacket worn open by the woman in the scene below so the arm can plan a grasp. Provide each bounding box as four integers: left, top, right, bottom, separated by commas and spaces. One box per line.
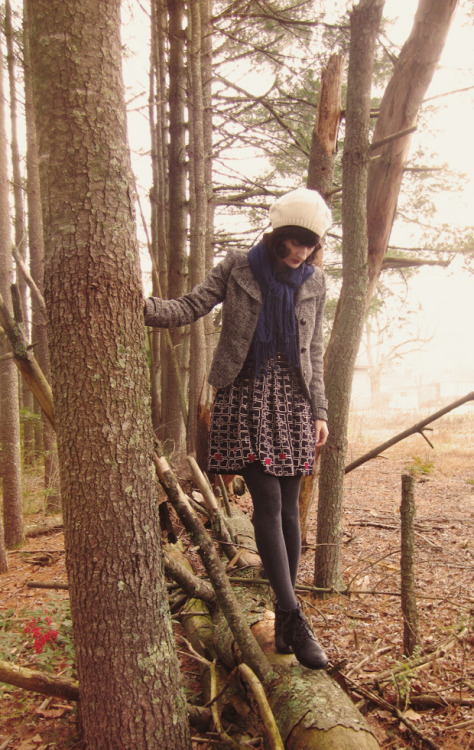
145, 250, 327, 419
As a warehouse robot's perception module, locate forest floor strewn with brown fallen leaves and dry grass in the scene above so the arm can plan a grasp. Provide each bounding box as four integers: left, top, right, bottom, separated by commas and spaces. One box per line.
0, 409, 474, 750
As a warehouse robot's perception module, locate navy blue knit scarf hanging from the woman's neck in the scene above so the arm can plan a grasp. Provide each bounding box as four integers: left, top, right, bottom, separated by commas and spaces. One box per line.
248, 242, 314, 376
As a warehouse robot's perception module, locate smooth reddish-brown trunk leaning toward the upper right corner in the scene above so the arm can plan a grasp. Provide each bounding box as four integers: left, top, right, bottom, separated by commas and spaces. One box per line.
367, 0, 458, 301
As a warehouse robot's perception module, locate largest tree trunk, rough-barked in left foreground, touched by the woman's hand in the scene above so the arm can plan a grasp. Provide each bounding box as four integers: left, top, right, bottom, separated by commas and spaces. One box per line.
27, 0, 190, 750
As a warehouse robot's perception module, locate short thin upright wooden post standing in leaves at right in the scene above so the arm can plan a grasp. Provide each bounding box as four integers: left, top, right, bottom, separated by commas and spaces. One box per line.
400, 473, 418, 656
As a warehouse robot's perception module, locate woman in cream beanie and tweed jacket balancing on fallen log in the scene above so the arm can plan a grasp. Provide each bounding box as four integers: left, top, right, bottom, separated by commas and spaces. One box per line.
145, 188, 331, 669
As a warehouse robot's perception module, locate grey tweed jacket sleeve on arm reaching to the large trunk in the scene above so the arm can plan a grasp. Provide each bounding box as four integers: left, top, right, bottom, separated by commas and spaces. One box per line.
145, 251, 234, 328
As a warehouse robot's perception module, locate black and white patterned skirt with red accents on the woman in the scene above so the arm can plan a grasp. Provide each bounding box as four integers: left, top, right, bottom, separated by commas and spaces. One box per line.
208, 357, 315, 477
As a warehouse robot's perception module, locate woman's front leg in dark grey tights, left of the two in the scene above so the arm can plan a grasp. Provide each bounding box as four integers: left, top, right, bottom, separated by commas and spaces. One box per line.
242, 463, 299, 610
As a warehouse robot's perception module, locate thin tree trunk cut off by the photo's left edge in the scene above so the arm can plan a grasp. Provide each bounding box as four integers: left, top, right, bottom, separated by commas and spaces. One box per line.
0, 32, 24, 549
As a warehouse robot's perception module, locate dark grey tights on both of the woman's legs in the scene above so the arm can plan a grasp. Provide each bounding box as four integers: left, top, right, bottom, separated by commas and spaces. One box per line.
242, 462, 301, 610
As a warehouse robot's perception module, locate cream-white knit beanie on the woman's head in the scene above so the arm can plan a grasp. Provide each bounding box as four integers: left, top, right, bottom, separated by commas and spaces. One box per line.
270, 188, 332, 237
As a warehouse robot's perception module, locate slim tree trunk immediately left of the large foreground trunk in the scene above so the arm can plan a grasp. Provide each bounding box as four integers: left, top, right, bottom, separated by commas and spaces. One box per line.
23, 8, 61, 513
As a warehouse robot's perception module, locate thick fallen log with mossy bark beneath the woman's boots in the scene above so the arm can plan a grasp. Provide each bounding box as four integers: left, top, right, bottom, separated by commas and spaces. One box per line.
172, 540, 379, 750
